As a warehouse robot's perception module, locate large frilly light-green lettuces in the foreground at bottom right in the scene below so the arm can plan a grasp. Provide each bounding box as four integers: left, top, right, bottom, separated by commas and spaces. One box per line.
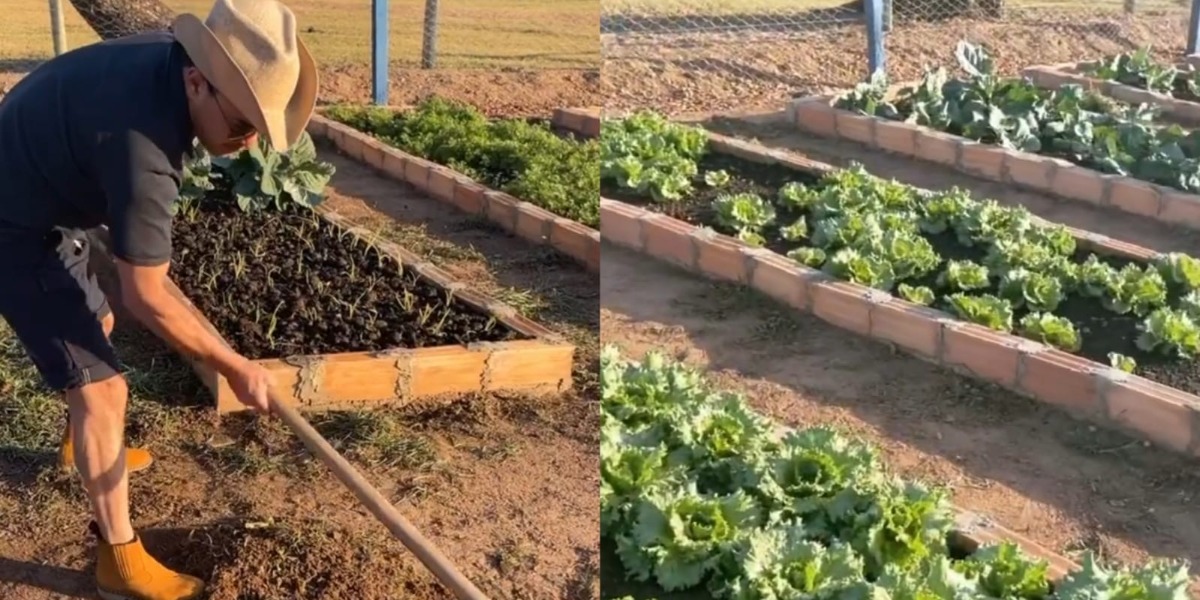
600, 347, 1190, 600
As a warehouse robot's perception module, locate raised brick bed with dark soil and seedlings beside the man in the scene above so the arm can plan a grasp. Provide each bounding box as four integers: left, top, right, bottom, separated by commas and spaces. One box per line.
115, 132, 574, 413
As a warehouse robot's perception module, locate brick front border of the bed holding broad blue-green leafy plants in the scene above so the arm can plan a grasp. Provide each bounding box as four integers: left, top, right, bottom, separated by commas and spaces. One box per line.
787, 95, 1200, 229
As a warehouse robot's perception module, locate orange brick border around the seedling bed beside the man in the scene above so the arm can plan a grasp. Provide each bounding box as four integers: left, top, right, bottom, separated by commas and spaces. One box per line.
90, 204, 576, 415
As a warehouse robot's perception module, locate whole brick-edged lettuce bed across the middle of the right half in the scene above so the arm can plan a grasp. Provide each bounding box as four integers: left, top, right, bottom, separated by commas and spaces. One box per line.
560, 104, 1200, 454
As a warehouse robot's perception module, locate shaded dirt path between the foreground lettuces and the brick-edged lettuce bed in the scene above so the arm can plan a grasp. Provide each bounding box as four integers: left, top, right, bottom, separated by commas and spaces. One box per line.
601, 241, 1200, 588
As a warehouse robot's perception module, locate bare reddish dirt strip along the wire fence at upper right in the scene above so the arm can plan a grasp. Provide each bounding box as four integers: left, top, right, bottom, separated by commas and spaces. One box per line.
601, 5, 1188, 114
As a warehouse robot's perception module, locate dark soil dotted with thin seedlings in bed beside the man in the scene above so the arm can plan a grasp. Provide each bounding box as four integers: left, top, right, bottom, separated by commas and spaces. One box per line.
172, 202, 522, 359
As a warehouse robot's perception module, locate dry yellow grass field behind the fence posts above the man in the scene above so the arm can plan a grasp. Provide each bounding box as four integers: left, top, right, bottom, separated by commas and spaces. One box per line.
0, 0, 600, 70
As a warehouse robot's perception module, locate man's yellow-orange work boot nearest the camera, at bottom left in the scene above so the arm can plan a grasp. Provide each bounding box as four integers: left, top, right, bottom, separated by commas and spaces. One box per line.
90, 522, 204, 600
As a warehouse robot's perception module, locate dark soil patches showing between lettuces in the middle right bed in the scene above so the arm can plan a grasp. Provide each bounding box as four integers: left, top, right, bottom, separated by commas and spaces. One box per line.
602, 154, 1200, 394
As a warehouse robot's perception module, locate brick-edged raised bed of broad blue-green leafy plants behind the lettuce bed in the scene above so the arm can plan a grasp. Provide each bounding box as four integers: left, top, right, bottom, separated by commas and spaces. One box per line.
790, 44, 1200, 228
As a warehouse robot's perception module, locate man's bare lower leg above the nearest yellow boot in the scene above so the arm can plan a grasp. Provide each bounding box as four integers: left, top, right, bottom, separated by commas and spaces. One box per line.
67, 376, 133, 544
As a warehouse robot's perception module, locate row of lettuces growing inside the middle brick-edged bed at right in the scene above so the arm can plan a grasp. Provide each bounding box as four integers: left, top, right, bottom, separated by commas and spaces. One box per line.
601, 108, 1200, 371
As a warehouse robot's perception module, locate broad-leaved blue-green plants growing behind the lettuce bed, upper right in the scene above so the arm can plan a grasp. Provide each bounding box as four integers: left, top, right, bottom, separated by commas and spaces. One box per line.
835, 41, 1200, 192
